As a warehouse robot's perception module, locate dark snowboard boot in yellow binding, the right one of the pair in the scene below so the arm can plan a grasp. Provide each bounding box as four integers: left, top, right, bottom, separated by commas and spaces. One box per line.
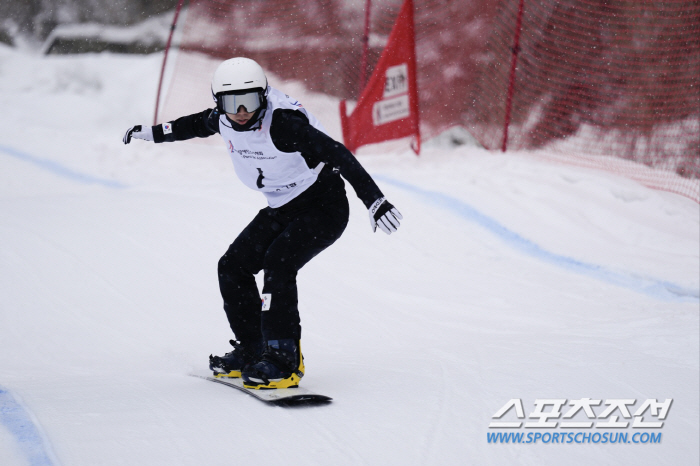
242, 340, 304, 390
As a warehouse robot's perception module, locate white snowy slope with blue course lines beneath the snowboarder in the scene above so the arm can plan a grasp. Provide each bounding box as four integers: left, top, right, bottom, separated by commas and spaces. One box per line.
0, 44, 700, 466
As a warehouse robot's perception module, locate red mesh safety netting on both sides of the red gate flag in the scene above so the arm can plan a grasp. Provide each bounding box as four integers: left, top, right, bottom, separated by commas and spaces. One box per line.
158, 0, 700, 202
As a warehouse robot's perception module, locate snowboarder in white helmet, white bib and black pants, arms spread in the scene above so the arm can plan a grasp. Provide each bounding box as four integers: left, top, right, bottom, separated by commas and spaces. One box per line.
123, 57, 403, 389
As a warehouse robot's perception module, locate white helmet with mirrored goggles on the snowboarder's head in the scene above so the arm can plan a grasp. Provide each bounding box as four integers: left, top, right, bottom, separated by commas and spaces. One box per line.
211, 57, 267, 117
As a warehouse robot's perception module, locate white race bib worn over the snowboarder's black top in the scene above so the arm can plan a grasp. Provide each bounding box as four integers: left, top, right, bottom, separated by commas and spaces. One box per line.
219, 87, 326, 208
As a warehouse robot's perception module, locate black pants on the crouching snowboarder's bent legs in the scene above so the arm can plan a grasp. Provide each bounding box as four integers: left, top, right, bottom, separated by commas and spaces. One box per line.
219, 168, 349, 342
